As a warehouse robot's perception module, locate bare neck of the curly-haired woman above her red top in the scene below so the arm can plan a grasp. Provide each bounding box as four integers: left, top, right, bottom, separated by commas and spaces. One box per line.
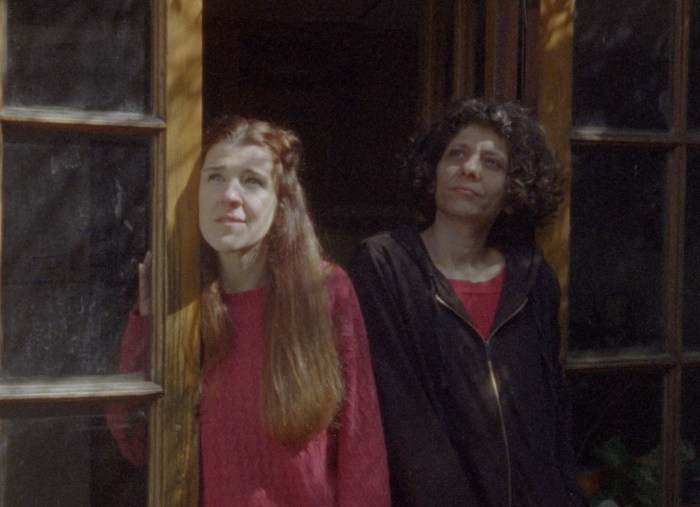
421, 219, 505, 282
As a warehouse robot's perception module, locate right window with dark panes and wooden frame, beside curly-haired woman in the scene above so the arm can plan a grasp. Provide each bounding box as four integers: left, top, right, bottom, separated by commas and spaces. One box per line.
539, 0, 700, 506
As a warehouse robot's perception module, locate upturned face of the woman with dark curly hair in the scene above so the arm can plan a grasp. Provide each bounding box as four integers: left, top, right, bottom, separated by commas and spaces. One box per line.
434, 124, 508, 226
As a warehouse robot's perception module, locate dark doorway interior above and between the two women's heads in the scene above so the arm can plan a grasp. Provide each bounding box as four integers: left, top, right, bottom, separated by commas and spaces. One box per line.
204, 0, 420, 264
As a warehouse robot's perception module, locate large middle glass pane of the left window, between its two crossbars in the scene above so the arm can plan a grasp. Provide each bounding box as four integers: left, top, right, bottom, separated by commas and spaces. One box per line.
0, 128, 150, 378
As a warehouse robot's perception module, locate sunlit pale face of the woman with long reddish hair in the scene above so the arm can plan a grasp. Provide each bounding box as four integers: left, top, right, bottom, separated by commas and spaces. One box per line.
199, 141, 277, 254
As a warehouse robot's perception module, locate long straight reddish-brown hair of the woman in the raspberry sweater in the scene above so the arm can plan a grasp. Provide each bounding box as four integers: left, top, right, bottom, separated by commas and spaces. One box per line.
200, 117, 345, 446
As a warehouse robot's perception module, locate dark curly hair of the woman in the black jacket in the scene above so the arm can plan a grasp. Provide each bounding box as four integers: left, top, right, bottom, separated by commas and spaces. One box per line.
402, 99, 563, 244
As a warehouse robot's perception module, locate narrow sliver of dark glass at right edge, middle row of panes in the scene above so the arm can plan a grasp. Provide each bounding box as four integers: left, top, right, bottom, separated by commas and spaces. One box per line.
683, 149, 700, 348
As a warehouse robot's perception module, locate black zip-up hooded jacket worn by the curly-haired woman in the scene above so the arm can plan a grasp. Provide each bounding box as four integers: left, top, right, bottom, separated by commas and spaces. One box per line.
350, 227, 585, 507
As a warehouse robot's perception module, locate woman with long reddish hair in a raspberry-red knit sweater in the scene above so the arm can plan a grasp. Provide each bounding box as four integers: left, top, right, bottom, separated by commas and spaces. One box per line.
114, 117, 389, 507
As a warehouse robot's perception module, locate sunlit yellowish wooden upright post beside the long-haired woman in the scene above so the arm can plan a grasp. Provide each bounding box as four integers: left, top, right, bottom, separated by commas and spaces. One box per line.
149, 0, 202, 507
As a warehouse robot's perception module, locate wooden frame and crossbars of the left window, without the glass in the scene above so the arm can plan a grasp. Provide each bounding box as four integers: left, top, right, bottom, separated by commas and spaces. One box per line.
0, 0, 202, 506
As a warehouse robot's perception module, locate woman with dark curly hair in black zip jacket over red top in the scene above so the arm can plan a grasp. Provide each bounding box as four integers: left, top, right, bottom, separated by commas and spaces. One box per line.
351, 99, 585, 507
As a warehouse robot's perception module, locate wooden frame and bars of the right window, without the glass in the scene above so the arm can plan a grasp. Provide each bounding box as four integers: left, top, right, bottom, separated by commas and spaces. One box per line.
537, 0, 700, 506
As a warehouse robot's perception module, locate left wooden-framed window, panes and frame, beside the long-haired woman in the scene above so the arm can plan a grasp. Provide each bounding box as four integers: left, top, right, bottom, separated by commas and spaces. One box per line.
0, 0, 201, 507
